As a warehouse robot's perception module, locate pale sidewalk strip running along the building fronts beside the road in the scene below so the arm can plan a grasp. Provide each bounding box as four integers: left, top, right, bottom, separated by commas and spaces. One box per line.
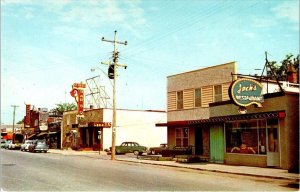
48, 149, 299, 182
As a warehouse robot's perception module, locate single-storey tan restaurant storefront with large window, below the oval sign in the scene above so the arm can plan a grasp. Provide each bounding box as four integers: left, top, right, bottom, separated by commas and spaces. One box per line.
210, 92, 299, 171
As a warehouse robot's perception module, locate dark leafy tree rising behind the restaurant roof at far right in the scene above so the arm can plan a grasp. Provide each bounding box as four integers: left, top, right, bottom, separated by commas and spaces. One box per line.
267, 54, 300, 83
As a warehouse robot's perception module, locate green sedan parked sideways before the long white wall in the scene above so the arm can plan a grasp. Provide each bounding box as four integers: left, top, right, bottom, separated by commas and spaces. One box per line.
110, 142, 147, 155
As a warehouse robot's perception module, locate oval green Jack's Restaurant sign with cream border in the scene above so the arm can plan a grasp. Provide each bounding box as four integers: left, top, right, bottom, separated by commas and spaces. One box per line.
229, 78, 264, 107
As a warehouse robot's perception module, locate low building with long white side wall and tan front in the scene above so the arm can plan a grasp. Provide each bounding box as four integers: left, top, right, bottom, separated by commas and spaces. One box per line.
61, 108, 167, 150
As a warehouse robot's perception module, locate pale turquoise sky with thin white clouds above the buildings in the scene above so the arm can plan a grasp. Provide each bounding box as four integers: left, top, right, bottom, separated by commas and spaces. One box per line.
1, 0, 299, 124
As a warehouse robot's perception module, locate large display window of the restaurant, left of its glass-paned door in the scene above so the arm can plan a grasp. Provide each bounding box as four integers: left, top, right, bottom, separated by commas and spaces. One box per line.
225, 120, 266, 154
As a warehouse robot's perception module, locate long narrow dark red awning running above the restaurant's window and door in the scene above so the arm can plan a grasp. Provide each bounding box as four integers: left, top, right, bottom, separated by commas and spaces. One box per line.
155, 111, 285, 127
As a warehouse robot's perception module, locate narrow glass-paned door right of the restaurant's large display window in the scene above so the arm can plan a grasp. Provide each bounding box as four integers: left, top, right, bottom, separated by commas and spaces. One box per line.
267, 121, 280, 167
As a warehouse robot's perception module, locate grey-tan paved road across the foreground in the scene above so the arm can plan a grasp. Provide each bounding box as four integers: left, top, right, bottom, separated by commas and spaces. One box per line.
1, 150, 296, 191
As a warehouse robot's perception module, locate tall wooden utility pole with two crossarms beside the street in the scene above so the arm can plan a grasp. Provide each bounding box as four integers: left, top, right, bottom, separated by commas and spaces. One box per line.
101, 31, 127, 160
